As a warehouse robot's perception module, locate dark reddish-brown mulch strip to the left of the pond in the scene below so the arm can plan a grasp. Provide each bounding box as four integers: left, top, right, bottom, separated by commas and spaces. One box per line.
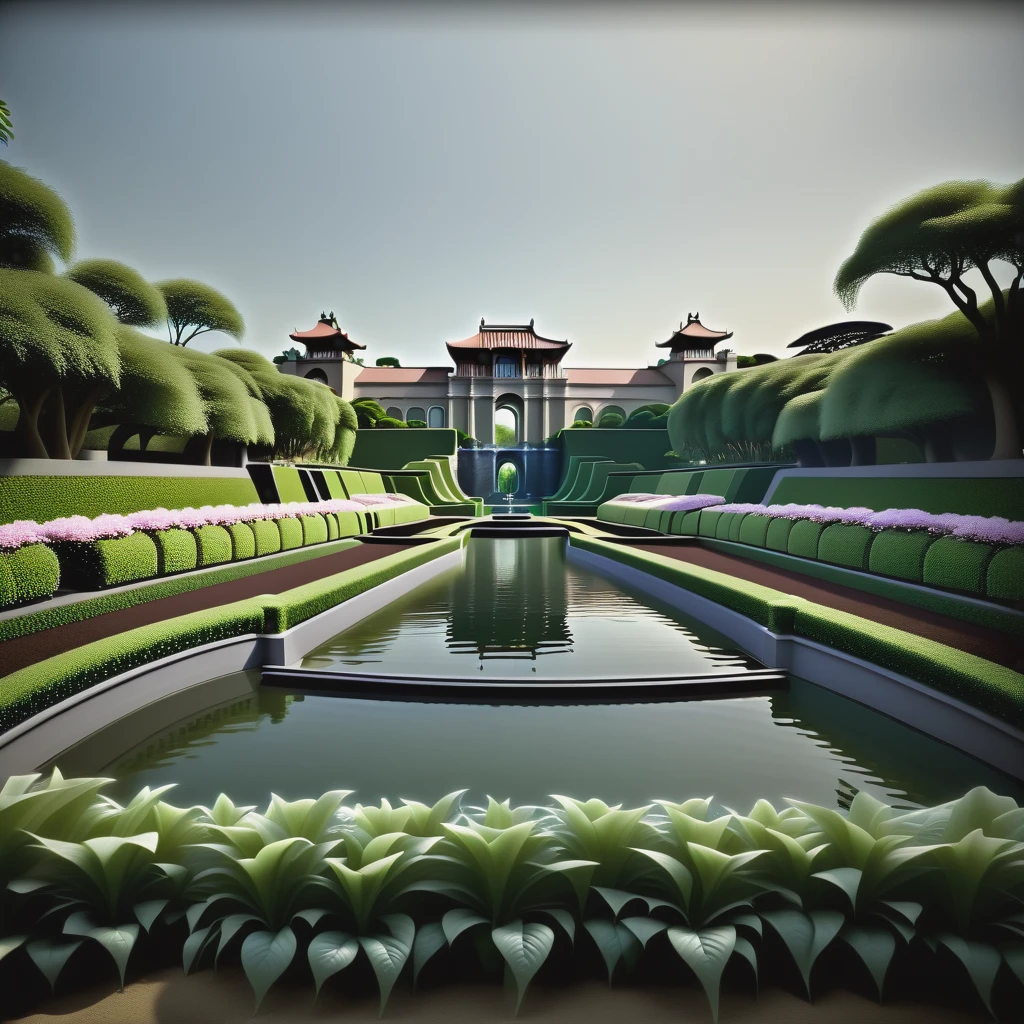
0, 543, 409, 676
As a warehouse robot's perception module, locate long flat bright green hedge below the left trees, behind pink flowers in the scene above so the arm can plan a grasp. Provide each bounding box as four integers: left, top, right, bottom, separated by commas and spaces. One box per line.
0, 475, 258, 522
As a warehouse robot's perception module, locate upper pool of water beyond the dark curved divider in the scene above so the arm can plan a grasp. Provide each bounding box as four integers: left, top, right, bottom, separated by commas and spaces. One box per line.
302, 537, 756, 679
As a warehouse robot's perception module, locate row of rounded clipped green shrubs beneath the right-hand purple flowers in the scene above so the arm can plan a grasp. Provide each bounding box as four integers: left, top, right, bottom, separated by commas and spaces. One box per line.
647, 506, 1024, 605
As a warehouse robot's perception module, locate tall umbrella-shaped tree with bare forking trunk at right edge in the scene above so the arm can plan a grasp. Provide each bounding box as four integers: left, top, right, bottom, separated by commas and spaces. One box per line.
835, 179, 1024, 459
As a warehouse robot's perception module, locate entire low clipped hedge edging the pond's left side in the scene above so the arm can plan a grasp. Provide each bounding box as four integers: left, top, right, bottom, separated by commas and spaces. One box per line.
0, 539, 462, 731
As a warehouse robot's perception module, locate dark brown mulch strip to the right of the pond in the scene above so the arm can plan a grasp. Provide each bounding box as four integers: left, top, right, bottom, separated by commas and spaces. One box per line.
630, 543, 1024, 671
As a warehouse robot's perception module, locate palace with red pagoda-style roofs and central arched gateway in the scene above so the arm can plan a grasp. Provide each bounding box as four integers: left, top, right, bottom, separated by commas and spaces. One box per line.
281, 313, 736, 444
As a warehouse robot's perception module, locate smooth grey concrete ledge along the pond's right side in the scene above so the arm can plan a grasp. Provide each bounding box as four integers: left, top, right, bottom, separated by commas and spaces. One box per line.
568, 547, 1024, 780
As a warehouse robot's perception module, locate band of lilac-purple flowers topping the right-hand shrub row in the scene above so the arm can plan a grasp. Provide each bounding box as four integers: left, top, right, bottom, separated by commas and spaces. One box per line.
712, 496, 1024, 544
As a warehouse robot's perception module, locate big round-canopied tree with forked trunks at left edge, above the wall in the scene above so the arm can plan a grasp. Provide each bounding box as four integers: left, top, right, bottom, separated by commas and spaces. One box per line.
0, 269, 121, 459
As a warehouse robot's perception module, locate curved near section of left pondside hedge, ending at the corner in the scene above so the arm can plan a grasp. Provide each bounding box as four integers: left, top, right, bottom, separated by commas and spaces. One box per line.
0, 598, 263, 731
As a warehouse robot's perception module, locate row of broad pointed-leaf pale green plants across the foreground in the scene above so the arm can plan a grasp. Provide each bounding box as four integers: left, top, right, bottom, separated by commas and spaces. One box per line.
0, 771, 1024, 1020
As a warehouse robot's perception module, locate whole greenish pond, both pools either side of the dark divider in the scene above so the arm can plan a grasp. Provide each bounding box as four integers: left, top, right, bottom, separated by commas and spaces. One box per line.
41, 538, 1024, 810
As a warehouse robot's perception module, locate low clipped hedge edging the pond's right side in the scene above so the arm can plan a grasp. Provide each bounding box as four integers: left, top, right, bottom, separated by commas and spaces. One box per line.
569, 536, 1024, 725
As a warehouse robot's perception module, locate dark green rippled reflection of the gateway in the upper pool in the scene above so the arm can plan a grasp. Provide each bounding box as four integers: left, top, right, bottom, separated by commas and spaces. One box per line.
447, 537, 572, 659
